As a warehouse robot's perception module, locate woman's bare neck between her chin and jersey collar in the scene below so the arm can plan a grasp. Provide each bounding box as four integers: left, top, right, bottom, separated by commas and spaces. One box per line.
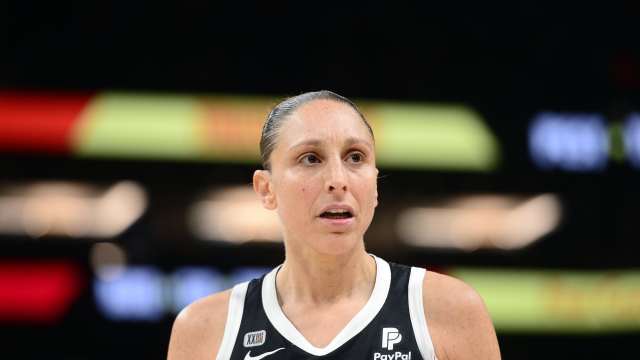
276, 244, 376, 305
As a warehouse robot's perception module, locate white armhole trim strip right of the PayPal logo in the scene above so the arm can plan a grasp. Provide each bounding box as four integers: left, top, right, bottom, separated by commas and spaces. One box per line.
409, 267, 436, 360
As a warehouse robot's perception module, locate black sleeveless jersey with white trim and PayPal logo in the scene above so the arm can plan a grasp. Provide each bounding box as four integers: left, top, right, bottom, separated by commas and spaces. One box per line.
216, 257, 435, 360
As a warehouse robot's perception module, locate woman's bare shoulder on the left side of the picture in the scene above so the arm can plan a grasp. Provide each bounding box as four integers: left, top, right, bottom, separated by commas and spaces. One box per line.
168, 290, 231, 360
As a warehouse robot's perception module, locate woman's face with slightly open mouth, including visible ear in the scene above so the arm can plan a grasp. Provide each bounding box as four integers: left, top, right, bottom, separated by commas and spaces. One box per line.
254, 100, 378, 255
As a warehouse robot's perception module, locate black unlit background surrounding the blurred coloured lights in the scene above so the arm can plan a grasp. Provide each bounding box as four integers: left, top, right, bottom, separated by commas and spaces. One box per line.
0, 0, 640, 359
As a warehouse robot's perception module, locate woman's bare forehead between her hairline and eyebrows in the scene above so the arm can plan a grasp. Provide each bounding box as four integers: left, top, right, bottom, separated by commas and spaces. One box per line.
279, 100, 372, 147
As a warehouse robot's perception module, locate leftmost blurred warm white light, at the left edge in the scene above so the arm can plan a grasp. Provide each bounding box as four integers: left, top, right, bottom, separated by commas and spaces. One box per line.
0, 181, 147, 238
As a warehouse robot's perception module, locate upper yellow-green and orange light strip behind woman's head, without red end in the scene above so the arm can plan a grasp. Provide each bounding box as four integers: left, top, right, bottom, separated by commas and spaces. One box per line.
73, 93, 499, 171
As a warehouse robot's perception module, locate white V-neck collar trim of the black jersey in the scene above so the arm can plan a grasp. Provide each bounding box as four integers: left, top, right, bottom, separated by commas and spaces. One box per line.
262, 255, 391, 356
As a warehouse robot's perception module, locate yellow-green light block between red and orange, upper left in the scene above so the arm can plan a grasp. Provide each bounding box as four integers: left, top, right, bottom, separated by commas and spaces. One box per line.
74, 93, 200, 159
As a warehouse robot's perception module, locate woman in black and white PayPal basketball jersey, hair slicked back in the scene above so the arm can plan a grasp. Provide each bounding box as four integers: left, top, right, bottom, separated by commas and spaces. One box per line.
169, 91, 500, 360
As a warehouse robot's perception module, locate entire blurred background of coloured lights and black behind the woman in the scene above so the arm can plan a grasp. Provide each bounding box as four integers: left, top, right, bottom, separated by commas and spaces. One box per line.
0, 0, 640, 359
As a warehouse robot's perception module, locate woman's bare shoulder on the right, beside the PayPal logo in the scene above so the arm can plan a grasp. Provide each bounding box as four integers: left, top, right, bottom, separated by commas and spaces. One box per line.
423, 271, 500, 360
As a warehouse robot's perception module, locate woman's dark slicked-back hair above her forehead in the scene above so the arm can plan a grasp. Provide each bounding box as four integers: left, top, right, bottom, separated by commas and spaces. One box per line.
260, 90, 373, 170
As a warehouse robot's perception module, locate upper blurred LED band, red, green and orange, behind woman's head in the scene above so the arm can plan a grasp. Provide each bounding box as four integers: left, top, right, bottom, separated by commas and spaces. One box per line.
0, 92, 500, 171
